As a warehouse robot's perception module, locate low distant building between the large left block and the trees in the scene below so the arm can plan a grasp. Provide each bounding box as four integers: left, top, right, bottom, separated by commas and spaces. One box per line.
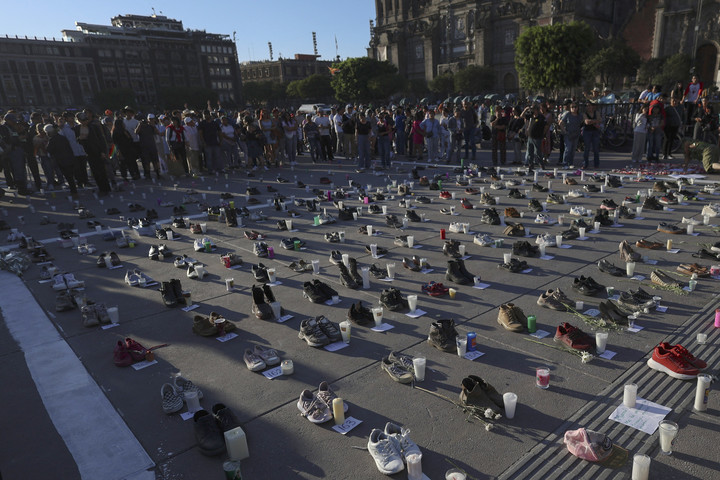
240, 53, 333, 83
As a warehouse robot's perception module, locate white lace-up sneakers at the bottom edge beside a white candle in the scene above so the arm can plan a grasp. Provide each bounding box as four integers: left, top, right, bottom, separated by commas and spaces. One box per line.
368, 422, 422, 475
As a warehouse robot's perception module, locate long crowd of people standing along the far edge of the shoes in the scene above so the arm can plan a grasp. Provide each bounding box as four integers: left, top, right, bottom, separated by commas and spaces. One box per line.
0, 76, 718, 195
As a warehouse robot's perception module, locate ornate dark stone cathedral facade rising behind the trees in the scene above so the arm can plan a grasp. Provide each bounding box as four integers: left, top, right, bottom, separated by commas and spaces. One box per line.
368, 0, 720, 93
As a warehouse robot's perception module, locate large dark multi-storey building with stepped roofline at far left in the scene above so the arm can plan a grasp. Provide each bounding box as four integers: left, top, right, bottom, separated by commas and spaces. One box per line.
0, 15, 241, 110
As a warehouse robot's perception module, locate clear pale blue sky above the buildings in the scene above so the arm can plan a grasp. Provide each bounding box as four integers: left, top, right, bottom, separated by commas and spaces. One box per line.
0, 0, 375, 62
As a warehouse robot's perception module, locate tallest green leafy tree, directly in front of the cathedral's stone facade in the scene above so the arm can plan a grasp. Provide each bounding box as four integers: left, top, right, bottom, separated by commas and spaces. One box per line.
515, 22, 595, 93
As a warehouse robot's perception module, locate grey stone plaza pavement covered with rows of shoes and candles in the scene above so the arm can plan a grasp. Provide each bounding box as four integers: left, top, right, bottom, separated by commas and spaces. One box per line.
0, 151, 720, 480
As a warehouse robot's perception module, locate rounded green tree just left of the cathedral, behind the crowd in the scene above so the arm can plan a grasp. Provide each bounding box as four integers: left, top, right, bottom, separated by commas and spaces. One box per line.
330, 57, 404, 102
